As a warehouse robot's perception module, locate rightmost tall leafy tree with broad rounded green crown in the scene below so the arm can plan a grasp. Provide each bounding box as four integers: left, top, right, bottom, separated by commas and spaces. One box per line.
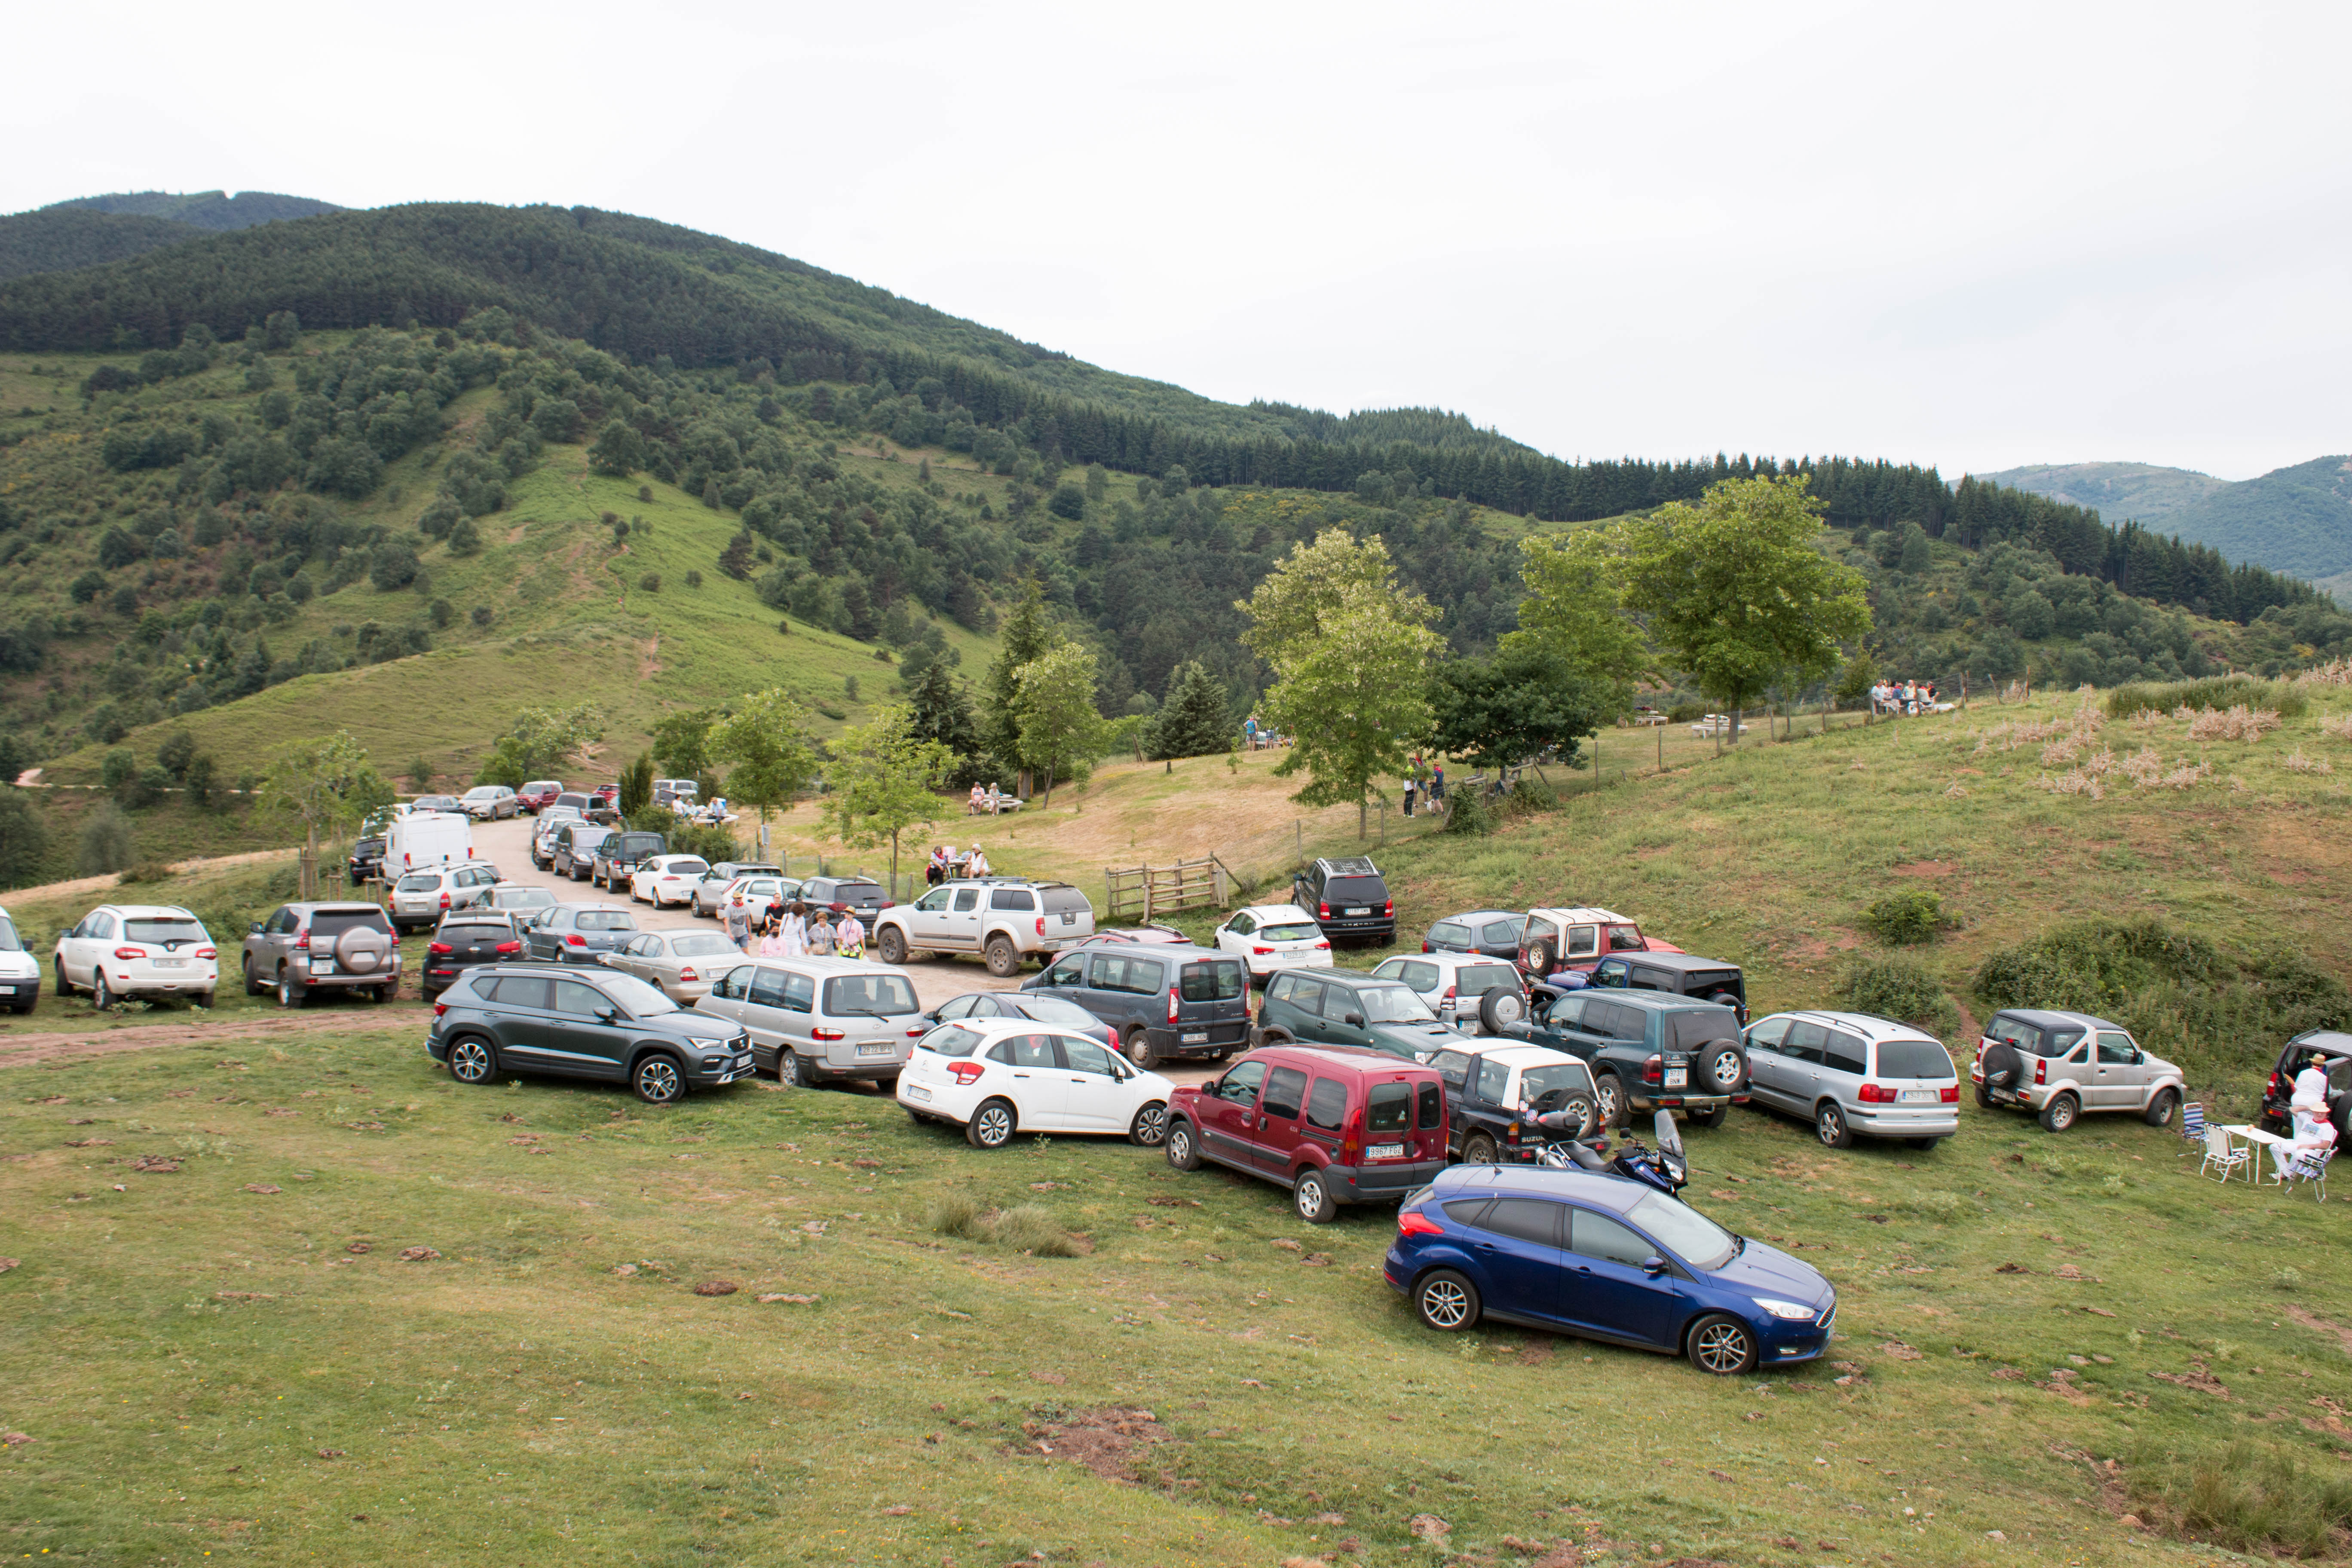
1625, 475, 1870, 738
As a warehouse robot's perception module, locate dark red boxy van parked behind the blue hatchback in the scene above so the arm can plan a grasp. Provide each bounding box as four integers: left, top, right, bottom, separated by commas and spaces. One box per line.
1167, 1046, 1446, 1225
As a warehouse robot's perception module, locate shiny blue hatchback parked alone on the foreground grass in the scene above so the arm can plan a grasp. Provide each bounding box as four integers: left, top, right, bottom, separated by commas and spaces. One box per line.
1383, 1166, 1837, 1378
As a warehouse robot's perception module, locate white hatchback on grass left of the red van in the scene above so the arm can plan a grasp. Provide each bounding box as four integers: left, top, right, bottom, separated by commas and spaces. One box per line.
898, 1018, 1174, 1149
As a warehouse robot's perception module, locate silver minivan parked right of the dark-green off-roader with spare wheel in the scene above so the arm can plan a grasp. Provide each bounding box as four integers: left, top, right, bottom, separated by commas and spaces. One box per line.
1745, 1013, 1959, 1149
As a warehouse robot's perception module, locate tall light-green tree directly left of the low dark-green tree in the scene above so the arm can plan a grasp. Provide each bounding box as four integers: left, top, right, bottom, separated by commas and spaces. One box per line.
1242, 529, 1444, 837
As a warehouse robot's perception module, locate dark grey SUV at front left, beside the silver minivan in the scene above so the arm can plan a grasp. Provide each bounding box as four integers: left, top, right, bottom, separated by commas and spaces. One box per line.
426, 964, 753, 1105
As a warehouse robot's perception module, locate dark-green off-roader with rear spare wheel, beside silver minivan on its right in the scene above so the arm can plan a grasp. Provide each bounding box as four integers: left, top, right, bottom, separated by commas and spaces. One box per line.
1503, 985, 1748, 1126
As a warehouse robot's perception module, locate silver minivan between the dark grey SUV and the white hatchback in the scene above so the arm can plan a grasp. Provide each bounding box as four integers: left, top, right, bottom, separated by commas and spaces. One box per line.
694, 959, 931, 1088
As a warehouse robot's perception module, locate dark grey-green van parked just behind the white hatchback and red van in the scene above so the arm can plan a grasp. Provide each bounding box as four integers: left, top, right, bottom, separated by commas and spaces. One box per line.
1021, 947, 1249, 1067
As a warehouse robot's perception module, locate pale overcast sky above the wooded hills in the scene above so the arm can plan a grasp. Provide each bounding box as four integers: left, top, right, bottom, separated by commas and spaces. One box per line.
0, 0, 2352, 480
